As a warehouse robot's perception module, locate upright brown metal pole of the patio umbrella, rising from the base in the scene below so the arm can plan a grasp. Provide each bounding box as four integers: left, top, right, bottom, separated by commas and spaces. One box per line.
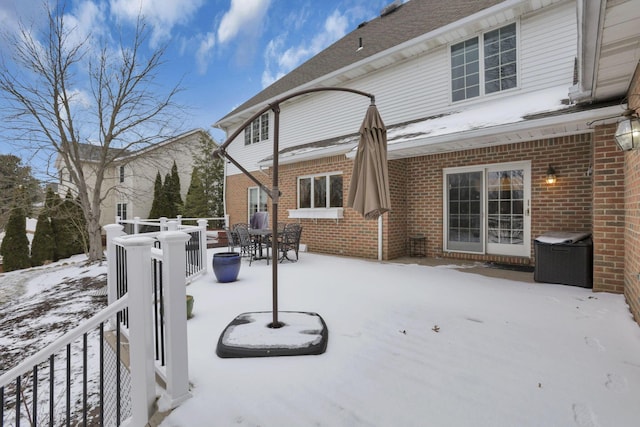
271, 103, 283, 328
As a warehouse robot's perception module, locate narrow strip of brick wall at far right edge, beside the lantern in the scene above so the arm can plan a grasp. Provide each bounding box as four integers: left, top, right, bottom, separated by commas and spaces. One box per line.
624, 69, 640, 323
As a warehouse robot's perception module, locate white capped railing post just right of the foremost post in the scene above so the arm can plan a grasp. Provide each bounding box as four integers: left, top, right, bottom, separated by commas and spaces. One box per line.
158, 231, 191, 411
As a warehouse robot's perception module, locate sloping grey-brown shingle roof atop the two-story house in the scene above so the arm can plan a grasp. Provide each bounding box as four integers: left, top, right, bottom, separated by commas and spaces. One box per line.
216, 0, 502, 125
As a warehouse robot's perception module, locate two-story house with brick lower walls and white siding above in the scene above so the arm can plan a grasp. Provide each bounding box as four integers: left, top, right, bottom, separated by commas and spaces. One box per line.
215, 0, 640, 315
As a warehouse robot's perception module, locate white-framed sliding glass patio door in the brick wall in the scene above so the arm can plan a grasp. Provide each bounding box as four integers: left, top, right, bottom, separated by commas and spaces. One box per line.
444, 162, 531, 256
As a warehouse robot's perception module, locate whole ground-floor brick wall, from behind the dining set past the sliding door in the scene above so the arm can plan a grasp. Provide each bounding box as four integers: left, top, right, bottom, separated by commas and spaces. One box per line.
227, 134, 594, 264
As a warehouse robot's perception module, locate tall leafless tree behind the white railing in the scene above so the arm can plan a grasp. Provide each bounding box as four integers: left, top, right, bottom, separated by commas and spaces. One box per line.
0, 3, 179, 262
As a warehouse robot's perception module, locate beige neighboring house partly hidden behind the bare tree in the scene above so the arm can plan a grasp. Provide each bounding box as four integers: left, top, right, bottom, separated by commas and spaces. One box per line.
56, 129, 211, 225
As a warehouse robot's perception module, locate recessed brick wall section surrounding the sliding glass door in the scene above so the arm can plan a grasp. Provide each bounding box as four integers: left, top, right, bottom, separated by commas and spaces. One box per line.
407, 134, 592, 264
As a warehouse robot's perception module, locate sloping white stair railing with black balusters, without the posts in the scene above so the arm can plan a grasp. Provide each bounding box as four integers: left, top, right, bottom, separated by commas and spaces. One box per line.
0, 295, 131, 426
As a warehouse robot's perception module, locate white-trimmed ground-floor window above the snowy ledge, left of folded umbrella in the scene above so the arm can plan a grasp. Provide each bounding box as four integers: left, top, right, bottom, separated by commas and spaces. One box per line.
298, 172, 342, 209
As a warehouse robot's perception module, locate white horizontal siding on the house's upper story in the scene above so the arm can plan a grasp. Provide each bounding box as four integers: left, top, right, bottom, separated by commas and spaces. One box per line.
228, 2, 577, 175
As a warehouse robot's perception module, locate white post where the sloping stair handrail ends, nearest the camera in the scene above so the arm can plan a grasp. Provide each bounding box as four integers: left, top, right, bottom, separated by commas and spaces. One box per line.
115, 236, 156, 426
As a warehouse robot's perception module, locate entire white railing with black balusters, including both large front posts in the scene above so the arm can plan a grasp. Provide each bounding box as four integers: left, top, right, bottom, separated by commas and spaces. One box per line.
0, 224, 198, 426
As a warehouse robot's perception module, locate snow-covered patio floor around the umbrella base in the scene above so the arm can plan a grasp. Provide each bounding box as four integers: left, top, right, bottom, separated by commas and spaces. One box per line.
161, 249, 640, 427
